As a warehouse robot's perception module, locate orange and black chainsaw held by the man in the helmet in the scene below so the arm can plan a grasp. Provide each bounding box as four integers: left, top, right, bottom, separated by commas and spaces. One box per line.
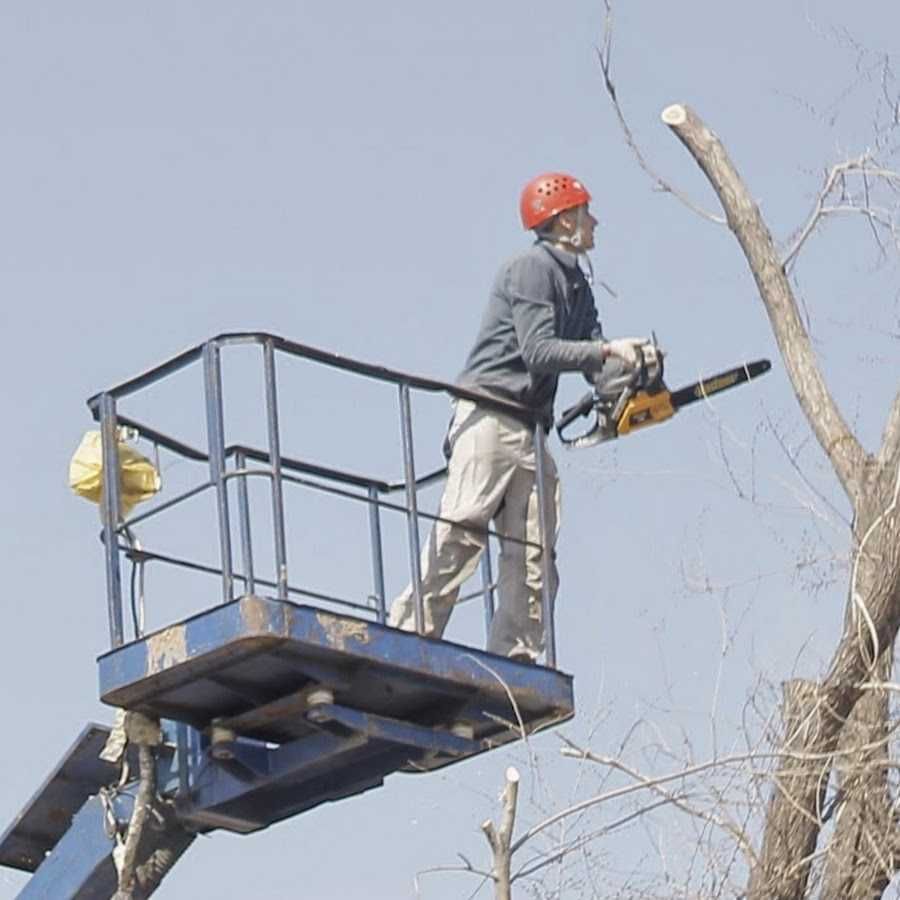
556, 339, 772, 450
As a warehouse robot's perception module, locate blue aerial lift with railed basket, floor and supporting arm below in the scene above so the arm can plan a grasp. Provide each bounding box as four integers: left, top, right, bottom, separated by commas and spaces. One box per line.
0, 333, 574, 900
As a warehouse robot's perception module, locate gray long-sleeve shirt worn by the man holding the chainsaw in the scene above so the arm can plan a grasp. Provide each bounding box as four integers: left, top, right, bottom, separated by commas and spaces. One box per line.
457, 241, 603, 426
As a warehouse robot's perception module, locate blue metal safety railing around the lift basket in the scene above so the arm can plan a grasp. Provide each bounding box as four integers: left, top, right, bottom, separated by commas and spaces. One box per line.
88, 332, 556, 666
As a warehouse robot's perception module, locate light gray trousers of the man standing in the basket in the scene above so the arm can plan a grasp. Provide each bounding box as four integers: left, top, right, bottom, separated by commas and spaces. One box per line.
388, 400, 559, 660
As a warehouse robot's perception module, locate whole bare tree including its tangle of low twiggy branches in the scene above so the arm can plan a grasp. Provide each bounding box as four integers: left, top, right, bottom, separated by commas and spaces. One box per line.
428, 8, 900, 900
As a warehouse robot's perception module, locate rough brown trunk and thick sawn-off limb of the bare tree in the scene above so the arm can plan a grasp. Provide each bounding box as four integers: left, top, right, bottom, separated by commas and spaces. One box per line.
662, 98, 900, 900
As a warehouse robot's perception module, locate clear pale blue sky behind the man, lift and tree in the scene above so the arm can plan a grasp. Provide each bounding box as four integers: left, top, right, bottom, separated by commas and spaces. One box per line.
0, 0, 900, 900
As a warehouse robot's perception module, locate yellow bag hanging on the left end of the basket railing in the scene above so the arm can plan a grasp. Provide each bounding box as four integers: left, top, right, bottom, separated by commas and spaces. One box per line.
69, 428, 162, 516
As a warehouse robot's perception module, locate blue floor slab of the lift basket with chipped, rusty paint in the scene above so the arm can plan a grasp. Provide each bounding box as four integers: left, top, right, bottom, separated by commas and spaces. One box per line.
99, 595, 574, 769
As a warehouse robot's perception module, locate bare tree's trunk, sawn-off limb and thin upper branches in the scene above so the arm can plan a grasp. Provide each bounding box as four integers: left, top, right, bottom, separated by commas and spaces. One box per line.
599, 0, 900, 900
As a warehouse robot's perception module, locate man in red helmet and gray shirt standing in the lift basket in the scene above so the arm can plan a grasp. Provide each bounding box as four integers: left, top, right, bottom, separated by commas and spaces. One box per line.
388, 173, 644, 662
